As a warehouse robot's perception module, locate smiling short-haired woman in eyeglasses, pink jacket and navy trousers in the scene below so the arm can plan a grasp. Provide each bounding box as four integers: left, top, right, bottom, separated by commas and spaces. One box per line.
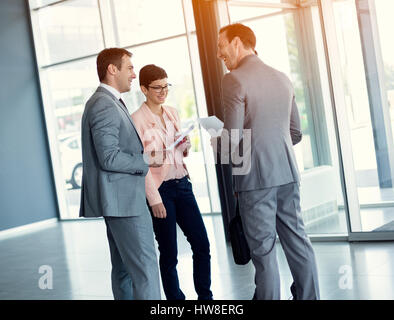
131, 64, 212, 300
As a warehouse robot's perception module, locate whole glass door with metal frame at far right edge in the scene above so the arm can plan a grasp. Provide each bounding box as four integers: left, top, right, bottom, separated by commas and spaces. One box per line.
320, 0, 394, 240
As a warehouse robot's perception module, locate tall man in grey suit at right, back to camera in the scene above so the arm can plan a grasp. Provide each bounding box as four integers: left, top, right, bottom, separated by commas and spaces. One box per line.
218, 24, 319, 299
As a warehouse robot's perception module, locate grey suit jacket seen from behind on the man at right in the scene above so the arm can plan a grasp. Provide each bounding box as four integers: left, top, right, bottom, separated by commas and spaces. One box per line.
222, 55, 302, 192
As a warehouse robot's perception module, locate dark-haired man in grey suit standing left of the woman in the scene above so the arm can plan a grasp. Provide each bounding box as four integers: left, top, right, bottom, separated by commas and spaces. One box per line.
80, 48, 160, 300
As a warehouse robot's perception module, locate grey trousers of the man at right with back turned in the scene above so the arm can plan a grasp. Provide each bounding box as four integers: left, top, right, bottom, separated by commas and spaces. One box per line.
238, 183, 320, 300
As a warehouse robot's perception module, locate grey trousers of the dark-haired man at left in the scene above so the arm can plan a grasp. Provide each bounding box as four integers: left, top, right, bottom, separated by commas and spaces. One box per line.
104, 213, 161, 300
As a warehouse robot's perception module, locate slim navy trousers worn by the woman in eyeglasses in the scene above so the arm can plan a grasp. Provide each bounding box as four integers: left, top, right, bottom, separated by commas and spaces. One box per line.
152, 177, 212, 300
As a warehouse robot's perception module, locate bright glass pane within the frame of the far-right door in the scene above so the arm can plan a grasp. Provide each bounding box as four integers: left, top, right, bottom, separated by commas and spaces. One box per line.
333, 0, 394, 232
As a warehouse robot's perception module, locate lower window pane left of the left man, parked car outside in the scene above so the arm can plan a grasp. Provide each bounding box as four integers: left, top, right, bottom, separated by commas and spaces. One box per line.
41, 58, 99, 219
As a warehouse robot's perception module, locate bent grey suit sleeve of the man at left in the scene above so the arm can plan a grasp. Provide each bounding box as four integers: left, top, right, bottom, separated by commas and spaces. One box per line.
90, 100, 148, 175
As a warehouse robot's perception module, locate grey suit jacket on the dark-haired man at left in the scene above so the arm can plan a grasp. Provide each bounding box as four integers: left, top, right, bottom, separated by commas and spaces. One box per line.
80, 87, 149, 217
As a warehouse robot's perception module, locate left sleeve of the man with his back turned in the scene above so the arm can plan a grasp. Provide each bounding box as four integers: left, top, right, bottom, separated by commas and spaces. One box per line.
221, 73, 245, 151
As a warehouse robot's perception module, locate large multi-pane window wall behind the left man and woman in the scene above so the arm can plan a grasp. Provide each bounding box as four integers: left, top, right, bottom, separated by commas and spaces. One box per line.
30, 0, 220, 219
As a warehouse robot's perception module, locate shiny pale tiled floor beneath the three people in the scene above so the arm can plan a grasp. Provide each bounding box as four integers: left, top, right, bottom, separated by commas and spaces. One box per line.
0, 216, 394, 300
